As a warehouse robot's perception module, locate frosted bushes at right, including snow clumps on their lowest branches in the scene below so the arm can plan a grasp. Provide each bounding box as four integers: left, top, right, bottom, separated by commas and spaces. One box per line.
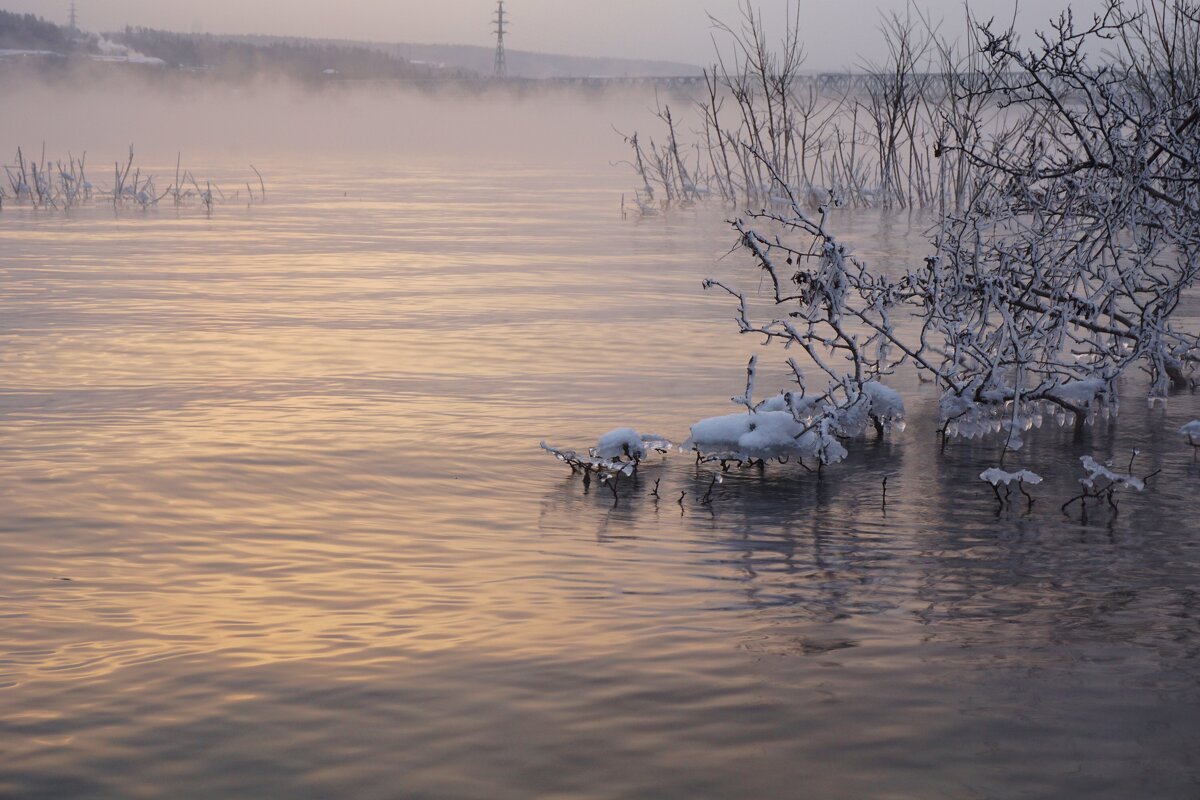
549, 0, 1200, 509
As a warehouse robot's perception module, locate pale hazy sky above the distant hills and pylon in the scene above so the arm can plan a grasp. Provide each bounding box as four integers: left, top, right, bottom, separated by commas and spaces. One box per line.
0, 0, 1100, 70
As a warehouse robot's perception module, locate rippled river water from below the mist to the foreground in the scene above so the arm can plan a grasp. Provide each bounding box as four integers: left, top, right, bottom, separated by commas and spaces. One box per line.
0, 153, 1200, 799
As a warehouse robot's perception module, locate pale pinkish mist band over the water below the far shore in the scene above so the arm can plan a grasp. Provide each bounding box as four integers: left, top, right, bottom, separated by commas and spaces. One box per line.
0, 76, 676, 167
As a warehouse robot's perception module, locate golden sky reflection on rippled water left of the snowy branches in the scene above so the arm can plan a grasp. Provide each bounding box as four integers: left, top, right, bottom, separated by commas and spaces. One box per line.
0, 164, 753, 684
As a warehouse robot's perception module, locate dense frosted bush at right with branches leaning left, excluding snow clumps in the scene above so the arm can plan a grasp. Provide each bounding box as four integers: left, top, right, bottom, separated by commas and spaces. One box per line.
706, 0, 1200, 449
